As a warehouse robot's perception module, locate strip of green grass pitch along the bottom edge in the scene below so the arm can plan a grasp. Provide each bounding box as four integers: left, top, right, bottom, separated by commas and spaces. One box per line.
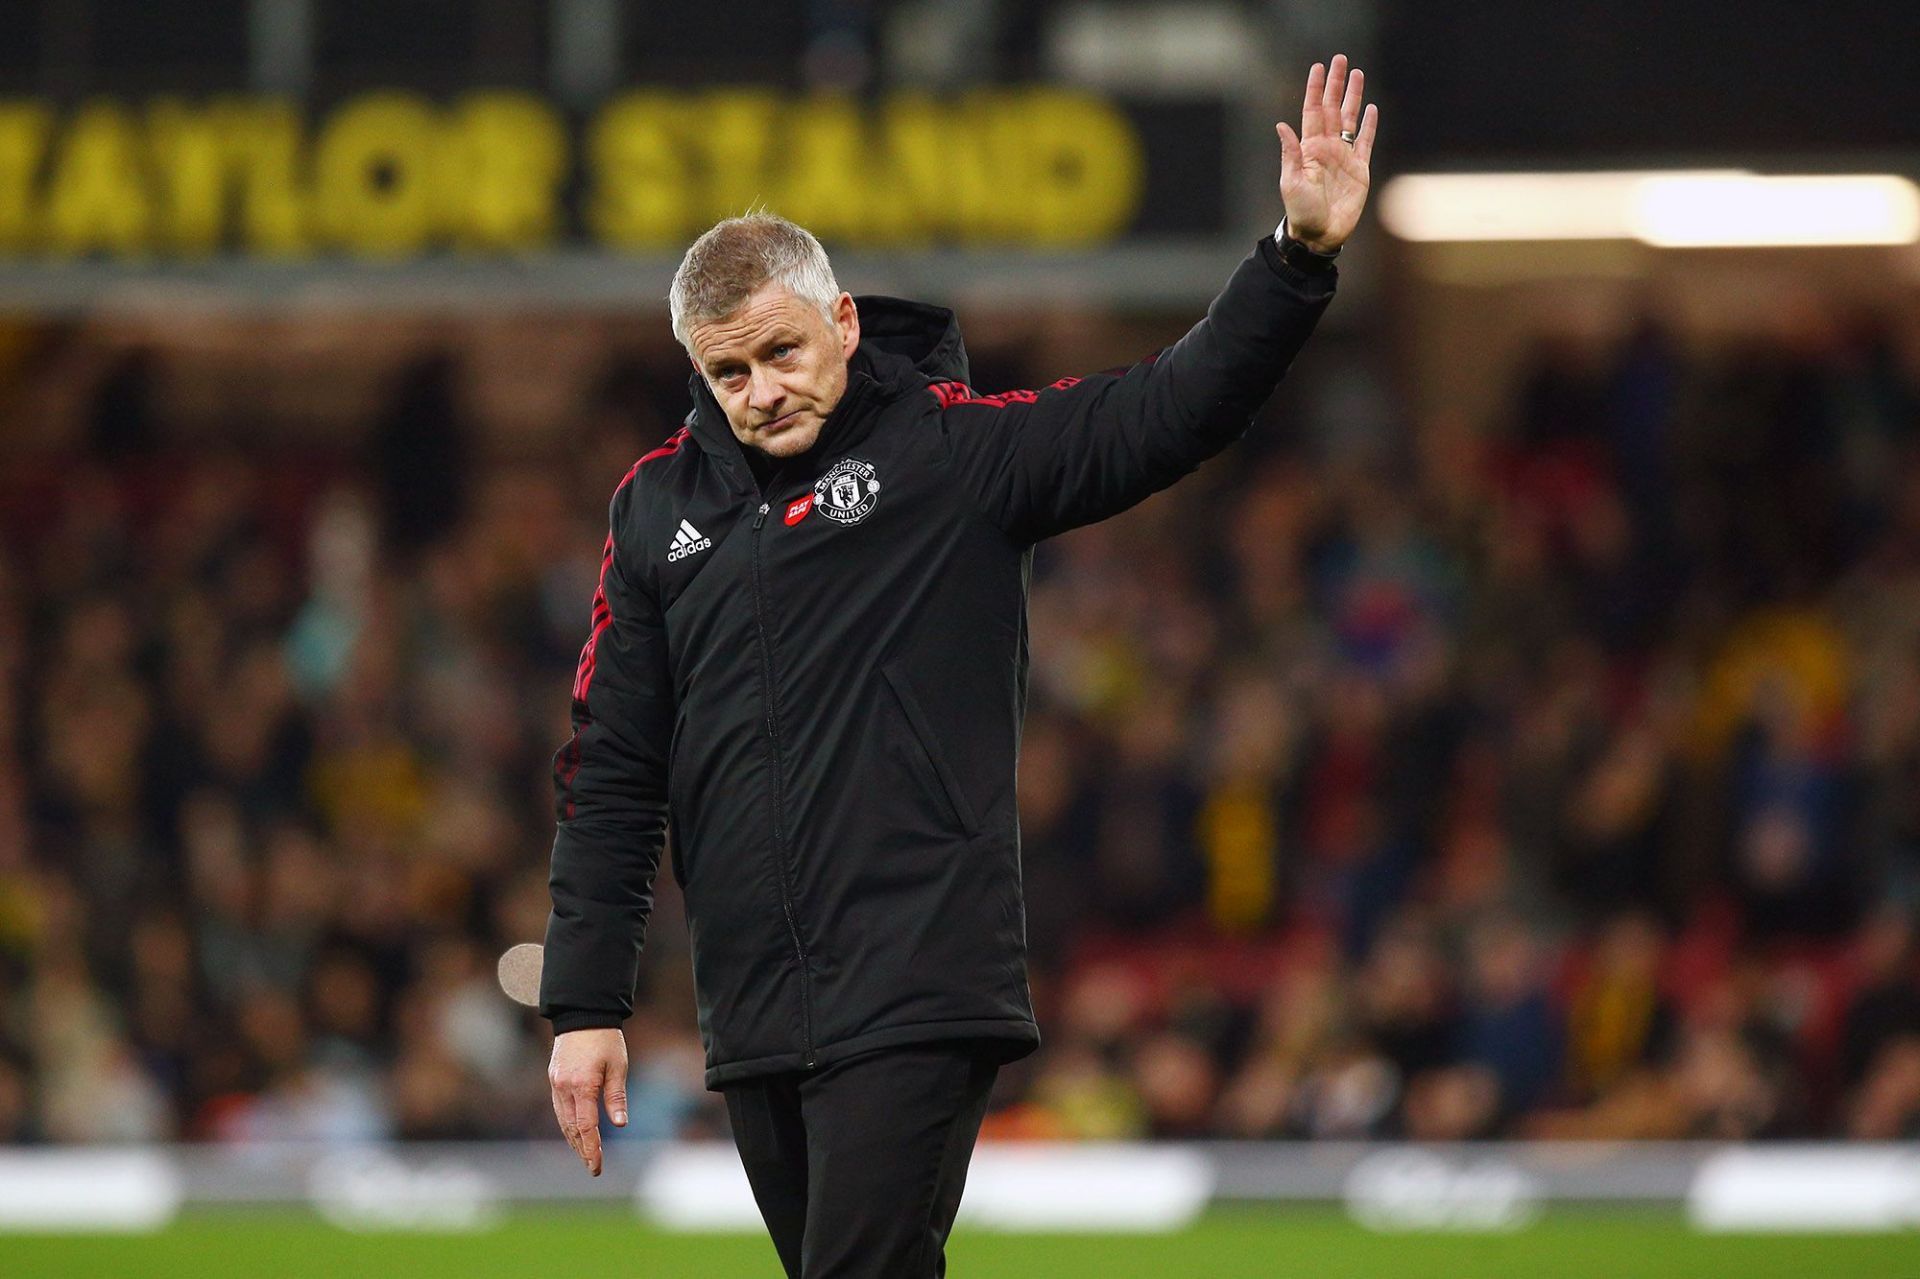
0, 1208, 1920, 1279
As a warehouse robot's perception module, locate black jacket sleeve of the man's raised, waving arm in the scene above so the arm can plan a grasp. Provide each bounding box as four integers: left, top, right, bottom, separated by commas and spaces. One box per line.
931, 236, 1334, 542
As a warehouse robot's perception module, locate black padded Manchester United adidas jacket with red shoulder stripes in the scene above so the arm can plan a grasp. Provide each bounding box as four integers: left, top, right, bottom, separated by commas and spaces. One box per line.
541, 238, 1334, 1089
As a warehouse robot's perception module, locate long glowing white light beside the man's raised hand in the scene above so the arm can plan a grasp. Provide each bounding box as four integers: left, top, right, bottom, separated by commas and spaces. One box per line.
1380, 169, 1920, 248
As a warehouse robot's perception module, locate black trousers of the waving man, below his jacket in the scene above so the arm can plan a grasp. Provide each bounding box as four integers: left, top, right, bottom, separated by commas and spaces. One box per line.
724, 1041, 1000, 1279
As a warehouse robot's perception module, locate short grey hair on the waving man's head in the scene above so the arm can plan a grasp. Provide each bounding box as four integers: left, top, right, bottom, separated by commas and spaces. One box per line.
666, 213, 841, 355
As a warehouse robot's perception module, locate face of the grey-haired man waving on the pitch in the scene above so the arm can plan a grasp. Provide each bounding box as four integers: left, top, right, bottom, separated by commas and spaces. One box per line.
687, 284, 860, 457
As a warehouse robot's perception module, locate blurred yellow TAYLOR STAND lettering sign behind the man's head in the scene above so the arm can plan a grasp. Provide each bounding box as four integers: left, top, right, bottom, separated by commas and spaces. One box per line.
0, 88, 1146, 259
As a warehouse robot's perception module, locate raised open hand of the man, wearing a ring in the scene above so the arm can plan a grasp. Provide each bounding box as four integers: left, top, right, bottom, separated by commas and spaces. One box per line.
1273, 54, 1380, 253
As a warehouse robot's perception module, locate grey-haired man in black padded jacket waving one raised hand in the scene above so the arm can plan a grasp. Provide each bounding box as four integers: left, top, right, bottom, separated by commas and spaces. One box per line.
541, 56, 1379, 1279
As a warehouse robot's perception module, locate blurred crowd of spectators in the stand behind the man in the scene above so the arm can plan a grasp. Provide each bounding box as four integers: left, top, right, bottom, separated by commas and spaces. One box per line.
0, 307, 1920, 1143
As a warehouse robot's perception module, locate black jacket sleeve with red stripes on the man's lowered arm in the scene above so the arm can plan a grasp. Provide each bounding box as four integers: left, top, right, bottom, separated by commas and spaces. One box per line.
540, 467, 674, 1035
